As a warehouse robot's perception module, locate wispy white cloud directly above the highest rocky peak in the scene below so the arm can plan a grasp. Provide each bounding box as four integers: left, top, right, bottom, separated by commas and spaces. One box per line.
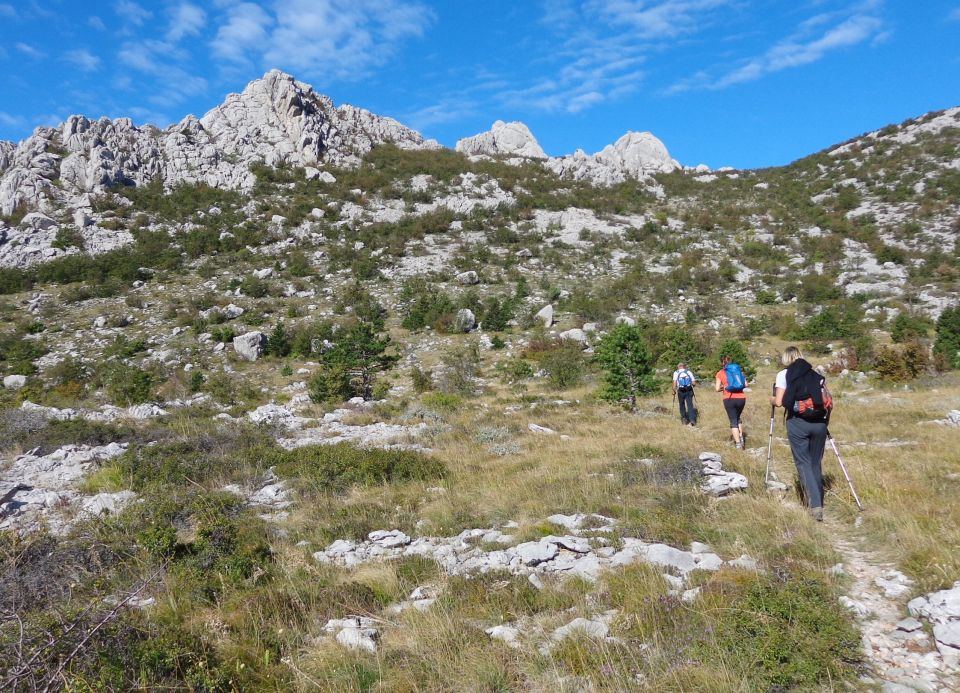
212, 0, 433, 79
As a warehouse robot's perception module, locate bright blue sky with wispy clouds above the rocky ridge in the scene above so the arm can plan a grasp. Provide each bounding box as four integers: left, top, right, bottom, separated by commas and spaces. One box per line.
0, 0, 960, 168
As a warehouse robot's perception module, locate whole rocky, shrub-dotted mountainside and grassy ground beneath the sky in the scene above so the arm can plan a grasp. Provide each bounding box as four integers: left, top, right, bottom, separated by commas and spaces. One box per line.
0, 72, 960, 691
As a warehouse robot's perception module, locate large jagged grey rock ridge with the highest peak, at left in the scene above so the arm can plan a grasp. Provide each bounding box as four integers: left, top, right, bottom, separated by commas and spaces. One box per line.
0, 70, 439, 223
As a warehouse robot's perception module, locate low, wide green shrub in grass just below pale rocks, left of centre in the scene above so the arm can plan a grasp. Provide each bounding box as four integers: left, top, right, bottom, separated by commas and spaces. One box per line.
271, 443, 446, 491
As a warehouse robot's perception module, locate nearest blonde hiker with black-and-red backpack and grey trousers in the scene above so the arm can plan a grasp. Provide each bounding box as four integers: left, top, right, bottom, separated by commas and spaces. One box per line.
770, 346, 833, 522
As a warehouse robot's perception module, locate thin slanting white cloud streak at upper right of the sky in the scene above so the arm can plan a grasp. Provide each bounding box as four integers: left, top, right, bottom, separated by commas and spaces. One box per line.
666, 6, 889, 94
